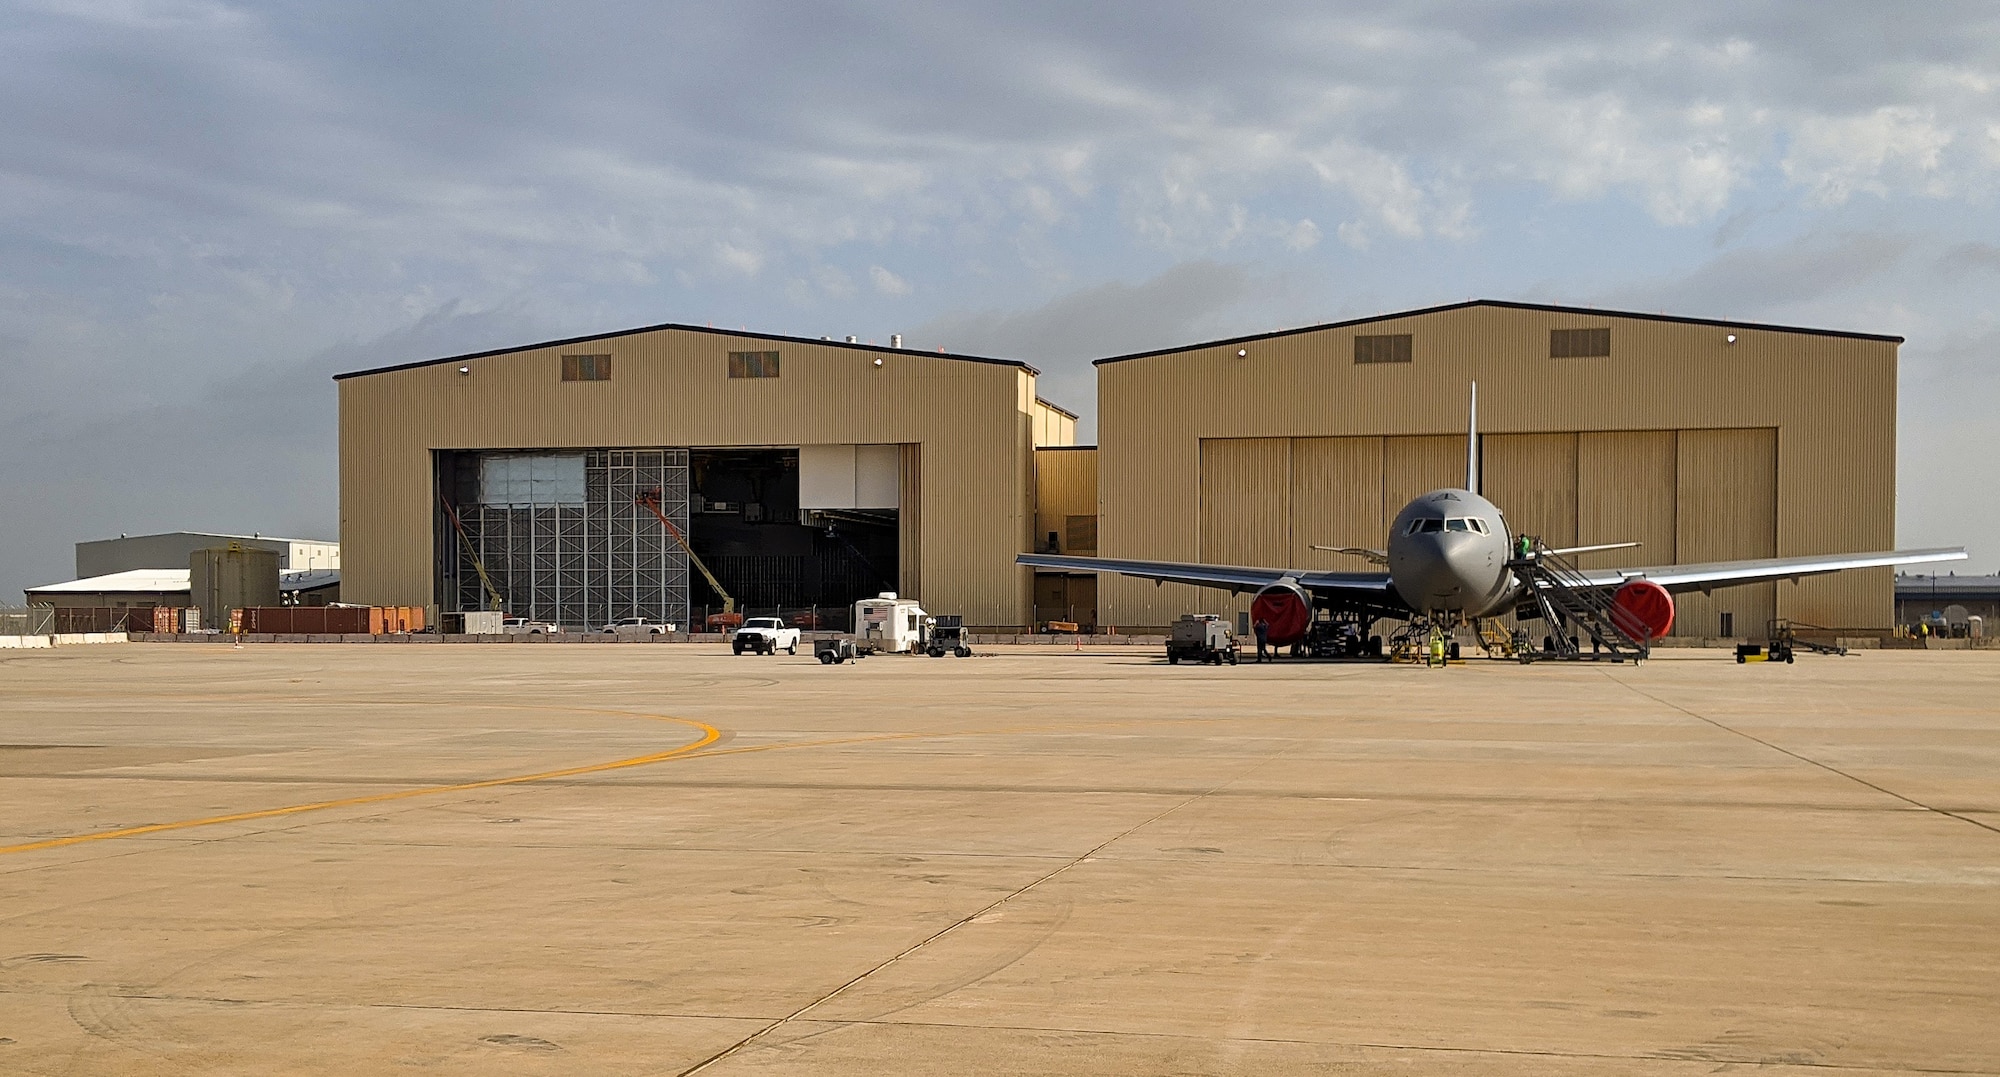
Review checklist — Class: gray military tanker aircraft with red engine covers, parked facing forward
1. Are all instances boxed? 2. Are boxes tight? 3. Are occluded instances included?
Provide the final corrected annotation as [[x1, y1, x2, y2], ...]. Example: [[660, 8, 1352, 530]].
[[1014, 384, 1966, 651]]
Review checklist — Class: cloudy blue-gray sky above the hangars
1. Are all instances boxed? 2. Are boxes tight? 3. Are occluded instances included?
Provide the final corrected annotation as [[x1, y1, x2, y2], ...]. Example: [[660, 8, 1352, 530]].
[[0, 0, 2000, 603]]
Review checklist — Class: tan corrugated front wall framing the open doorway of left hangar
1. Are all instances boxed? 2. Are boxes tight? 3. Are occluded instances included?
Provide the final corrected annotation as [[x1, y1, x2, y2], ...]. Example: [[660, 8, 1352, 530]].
[[338, 330, 1034, 625]]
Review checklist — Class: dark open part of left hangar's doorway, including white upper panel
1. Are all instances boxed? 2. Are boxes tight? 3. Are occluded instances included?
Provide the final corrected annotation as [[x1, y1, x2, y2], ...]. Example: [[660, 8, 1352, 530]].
[[688, 444, 900, 629]]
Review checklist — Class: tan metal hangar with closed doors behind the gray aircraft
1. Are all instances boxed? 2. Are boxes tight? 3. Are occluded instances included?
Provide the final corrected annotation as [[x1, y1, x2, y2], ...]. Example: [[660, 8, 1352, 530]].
[[1080, 300, 1902, 637]]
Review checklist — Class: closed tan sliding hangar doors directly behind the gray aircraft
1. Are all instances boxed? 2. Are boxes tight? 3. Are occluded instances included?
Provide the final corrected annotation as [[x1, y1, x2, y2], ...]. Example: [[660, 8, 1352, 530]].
[[1200, 428, 1778, 637]]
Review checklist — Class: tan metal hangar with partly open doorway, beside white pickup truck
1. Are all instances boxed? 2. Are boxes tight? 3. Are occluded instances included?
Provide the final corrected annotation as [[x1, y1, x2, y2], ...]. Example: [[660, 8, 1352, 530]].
[[336, 324, 1074, 629]]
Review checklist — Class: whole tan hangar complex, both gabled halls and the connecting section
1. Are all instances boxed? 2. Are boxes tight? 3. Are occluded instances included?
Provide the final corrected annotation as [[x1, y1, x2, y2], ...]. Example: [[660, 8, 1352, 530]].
[[340, 302, 1902, 635]]
